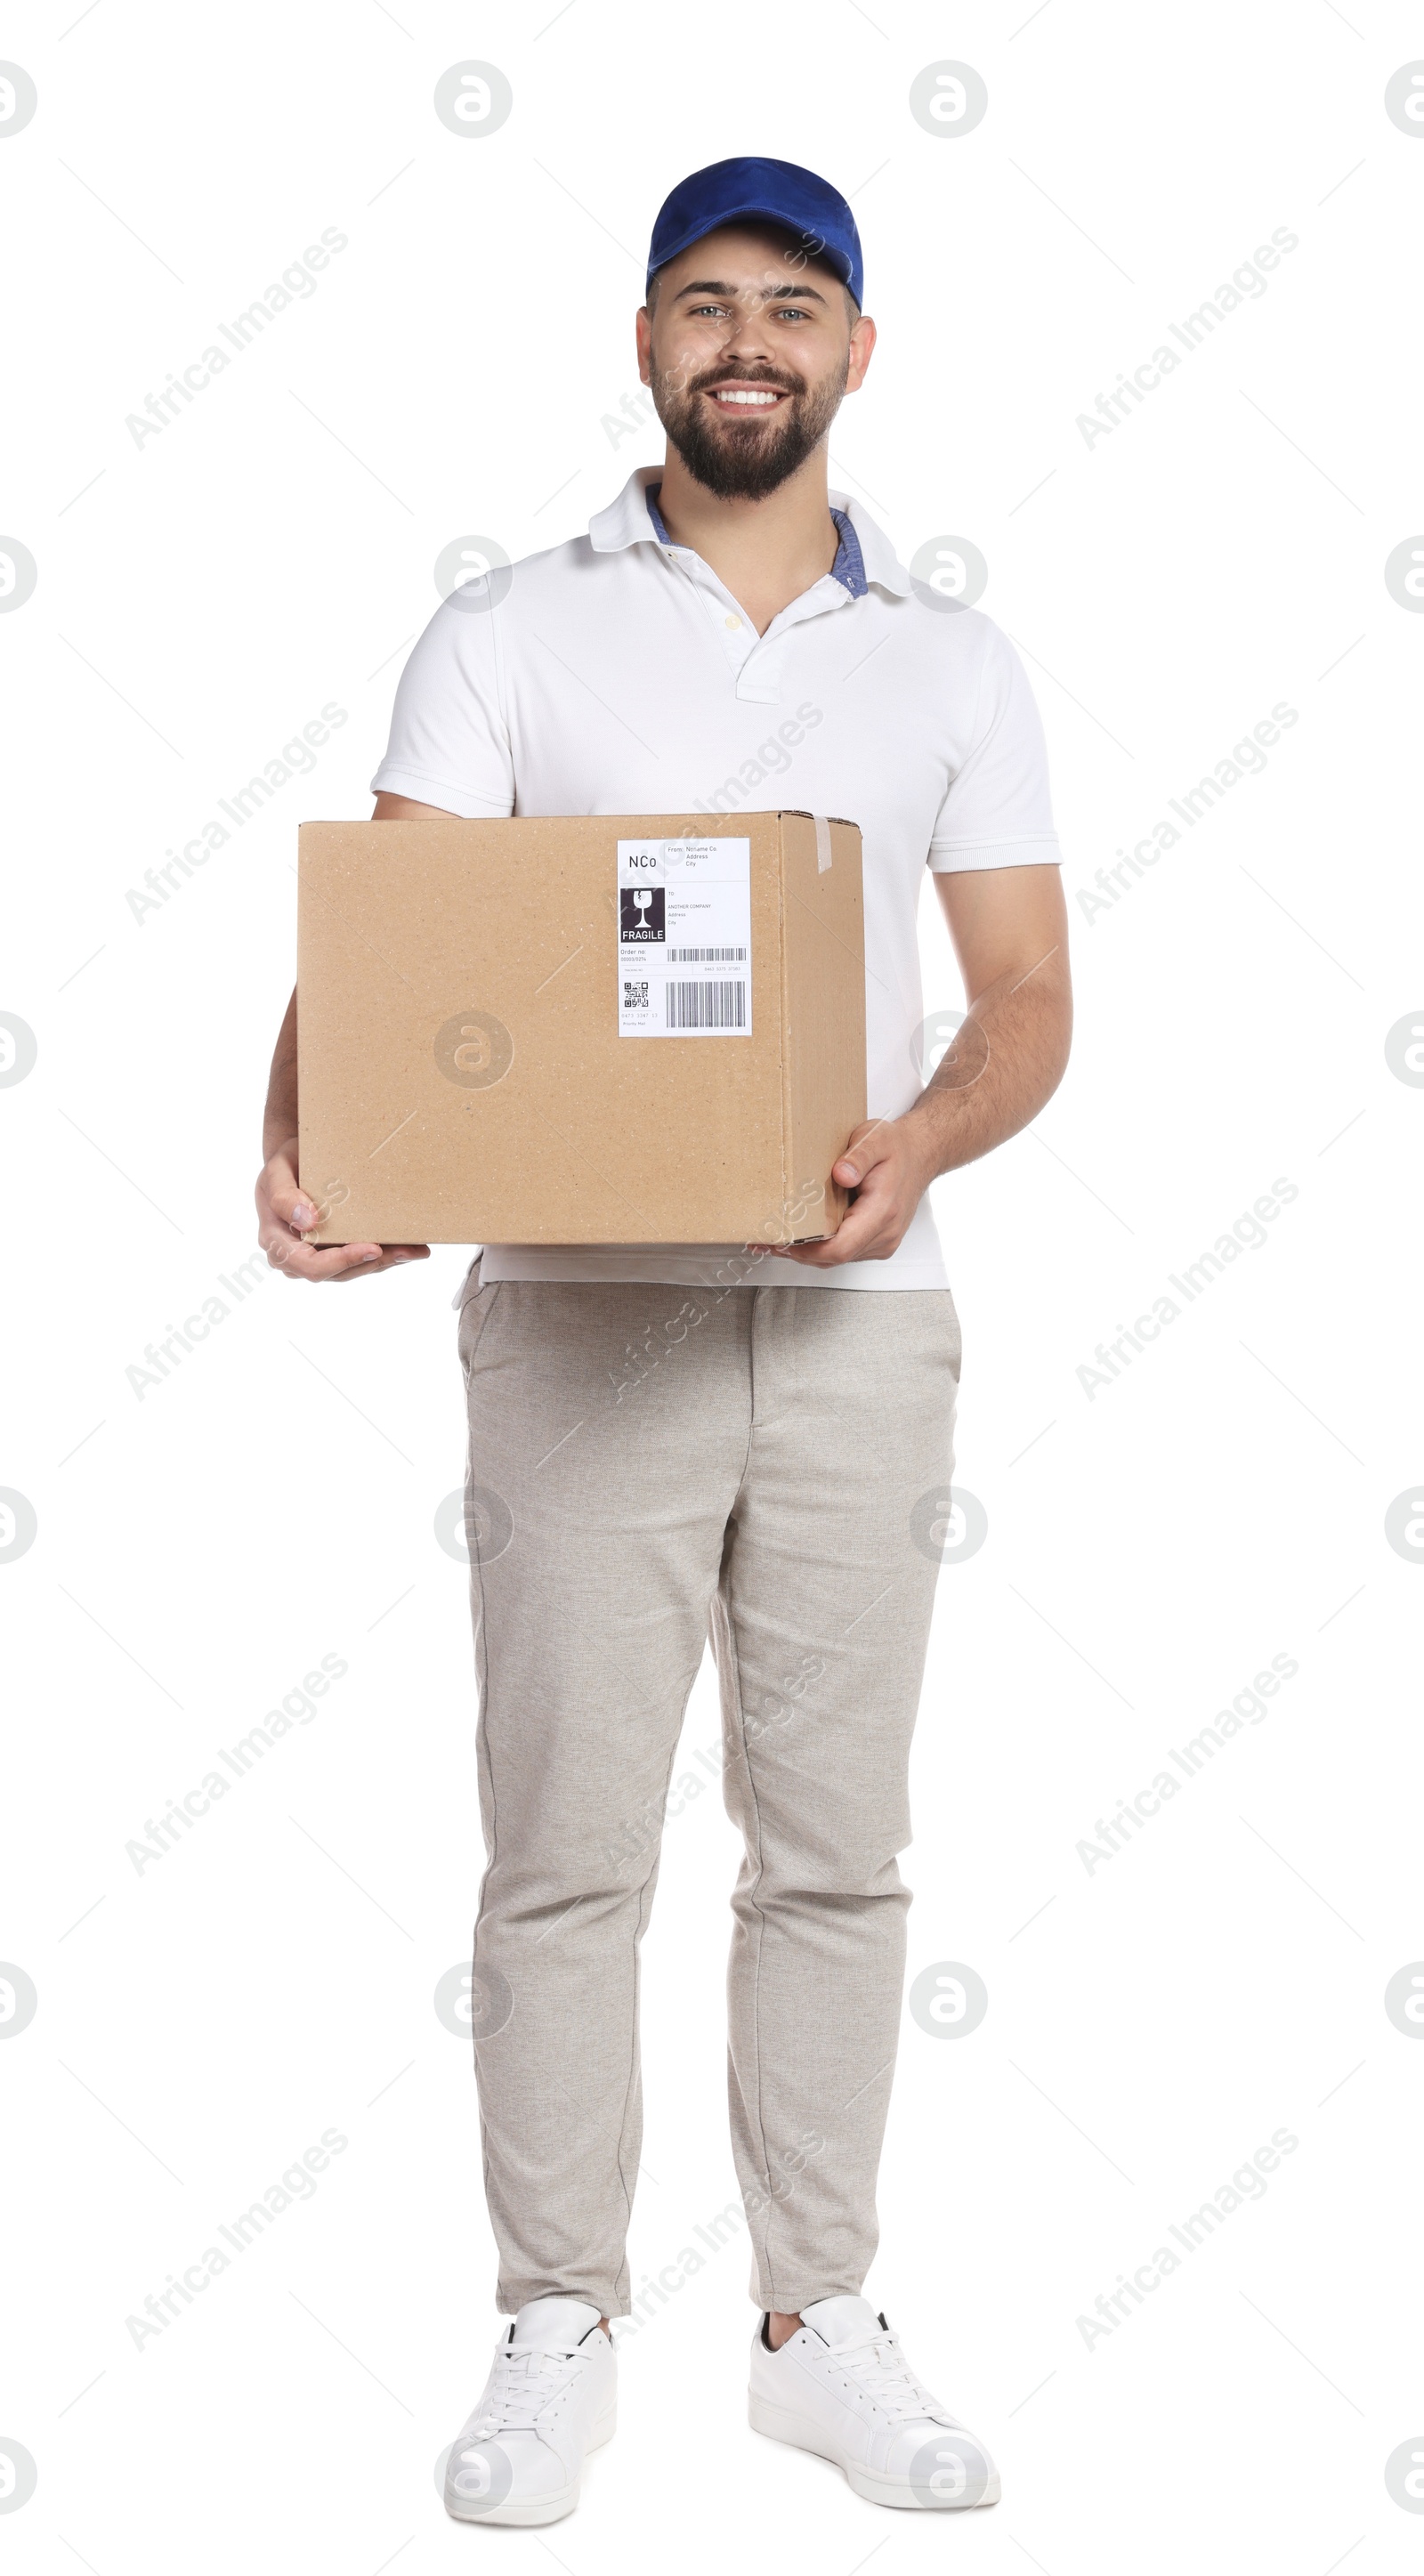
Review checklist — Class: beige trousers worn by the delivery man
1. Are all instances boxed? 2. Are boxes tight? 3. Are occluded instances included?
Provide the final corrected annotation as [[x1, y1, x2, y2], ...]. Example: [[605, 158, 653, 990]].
[[458, 1265, 960, 2316]]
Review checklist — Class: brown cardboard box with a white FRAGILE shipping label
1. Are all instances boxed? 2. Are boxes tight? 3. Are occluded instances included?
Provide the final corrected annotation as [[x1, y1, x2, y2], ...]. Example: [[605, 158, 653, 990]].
[[296, 812, 865, 1244]]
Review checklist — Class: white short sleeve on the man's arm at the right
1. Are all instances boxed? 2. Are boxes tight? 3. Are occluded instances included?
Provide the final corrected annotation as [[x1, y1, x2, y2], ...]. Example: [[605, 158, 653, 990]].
[[929, 619, 1064, 876]]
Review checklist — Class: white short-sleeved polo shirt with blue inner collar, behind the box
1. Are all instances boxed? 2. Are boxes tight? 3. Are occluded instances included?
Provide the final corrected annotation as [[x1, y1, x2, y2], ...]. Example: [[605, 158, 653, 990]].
[[371, 466, 1061, 1288]]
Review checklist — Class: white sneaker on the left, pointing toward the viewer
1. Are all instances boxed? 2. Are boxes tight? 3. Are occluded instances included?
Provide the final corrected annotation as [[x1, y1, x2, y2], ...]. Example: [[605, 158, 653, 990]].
[[446, 2297, 618, 2522]]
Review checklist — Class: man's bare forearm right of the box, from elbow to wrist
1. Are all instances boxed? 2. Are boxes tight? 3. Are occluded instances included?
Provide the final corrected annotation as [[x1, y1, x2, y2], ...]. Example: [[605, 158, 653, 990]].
[[904, 951, 1074, 1178]]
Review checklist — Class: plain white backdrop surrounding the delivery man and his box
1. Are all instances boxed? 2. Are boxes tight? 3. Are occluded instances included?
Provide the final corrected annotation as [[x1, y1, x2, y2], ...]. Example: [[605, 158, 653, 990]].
[[0, 0, 1424, 2576]]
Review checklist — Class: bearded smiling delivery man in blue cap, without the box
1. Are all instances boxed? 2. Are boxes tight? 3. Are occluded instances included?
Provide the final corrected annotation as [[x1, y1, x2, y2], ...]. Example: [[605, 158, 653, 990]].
[[257, 159, 1069, 2522]]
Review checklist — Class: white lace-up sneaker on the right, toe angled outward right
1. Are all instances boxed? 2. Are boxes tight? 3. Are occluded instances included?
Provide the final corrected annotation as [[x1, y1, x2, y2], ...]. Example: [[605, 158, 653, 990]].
[[749, 2297, 999, 2512]]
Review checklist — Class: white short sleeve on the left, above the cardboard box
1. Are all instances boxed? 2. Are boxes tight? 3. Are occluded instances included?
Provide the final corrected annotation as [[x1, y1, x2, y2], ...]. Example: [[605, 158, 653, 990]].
[[371, 593, 515, 819]]
